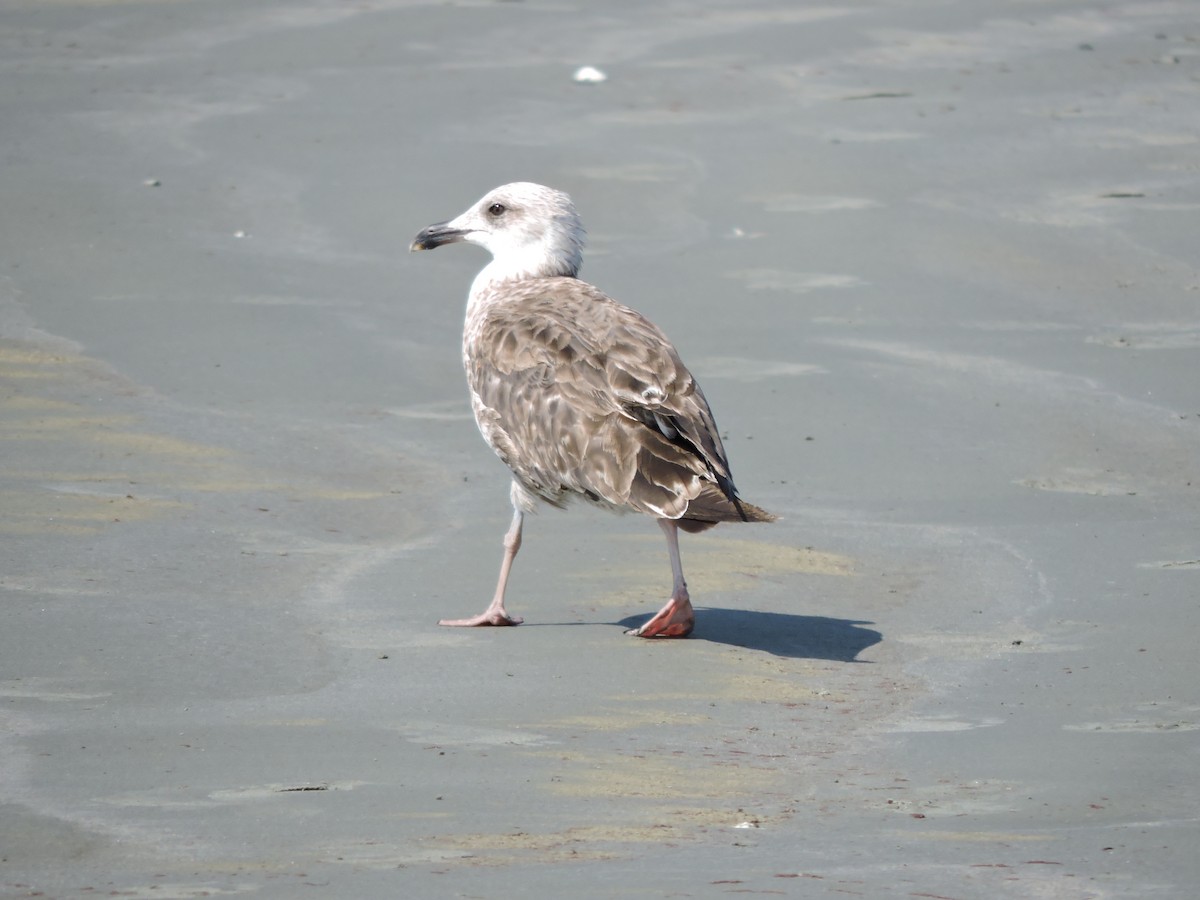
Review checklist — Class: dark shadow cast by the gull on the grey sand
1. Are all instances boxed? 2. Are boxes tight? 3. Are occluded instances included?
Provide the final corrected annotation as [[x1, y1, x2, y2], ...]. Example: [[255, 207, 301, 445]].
[[617, 606, 883, 662]]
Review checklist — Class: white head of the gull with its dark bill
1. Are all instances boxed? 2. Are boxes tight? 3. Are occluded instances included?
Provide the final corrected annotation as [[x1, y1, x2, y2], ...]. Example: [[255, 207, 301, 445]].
[[409, 181, 583, 283]]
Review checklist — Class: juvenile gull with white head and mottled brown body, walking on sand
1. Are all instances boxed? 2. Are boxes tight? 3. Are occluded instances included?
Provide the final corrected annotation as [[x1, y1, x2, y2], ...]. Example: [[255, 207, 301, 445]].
[[410, 182, 775, 637]]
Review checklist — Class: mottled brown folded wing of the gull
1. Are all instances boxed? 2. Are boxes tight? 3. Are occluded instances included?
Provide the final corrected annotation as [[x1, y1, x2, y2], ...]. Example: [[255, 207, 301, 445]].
[[466, 278, 745, 522]]
